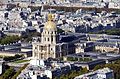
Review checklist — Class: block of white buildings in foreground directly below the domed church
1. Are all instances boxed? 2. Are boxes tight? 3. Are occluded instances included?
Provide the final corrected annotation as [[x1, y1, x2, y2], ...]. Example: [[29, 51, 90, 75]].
[[17, 59, 80, 79]]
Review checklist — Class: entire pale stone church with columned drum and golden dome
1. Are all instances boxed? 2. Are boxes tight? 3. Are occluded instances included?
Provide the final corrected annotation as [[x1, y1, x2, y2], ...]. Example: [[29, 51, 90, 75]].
[[33, 14, 68, 59]]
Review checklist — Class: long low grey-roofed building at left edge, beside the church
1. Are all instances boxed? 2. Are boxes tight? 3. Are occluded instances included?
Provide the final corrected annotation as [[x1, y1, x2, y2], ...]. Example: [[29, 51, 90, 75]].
[[0, 43, 32, 57]]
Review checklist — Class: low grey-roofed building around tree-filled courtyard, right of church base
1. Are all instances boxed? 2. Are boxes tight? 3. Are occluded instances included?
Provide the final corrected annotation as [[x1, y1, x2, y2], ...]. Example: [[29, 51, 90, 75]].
[[63, 52, 120, 70]]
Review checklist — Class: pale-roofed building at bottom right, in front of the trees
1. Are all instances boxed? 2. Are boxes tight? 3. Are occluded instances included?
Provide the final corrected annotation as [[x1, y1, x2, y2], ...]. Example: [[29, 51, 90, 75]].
[[74, 68, 114, 79]]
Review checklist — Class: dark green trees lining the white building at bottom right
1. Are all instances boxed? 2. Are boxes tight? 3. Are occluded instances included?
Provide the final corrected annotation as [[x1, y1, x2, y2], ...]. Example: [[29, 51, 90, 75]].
[[54, 60, 120, 79]]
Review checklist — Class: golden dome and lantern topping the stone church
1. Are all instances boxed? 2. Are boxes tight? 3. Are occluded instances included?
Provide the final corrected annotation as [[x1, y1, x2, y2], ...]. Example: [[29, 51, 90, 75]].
[[44, 14, 56, 29]]
